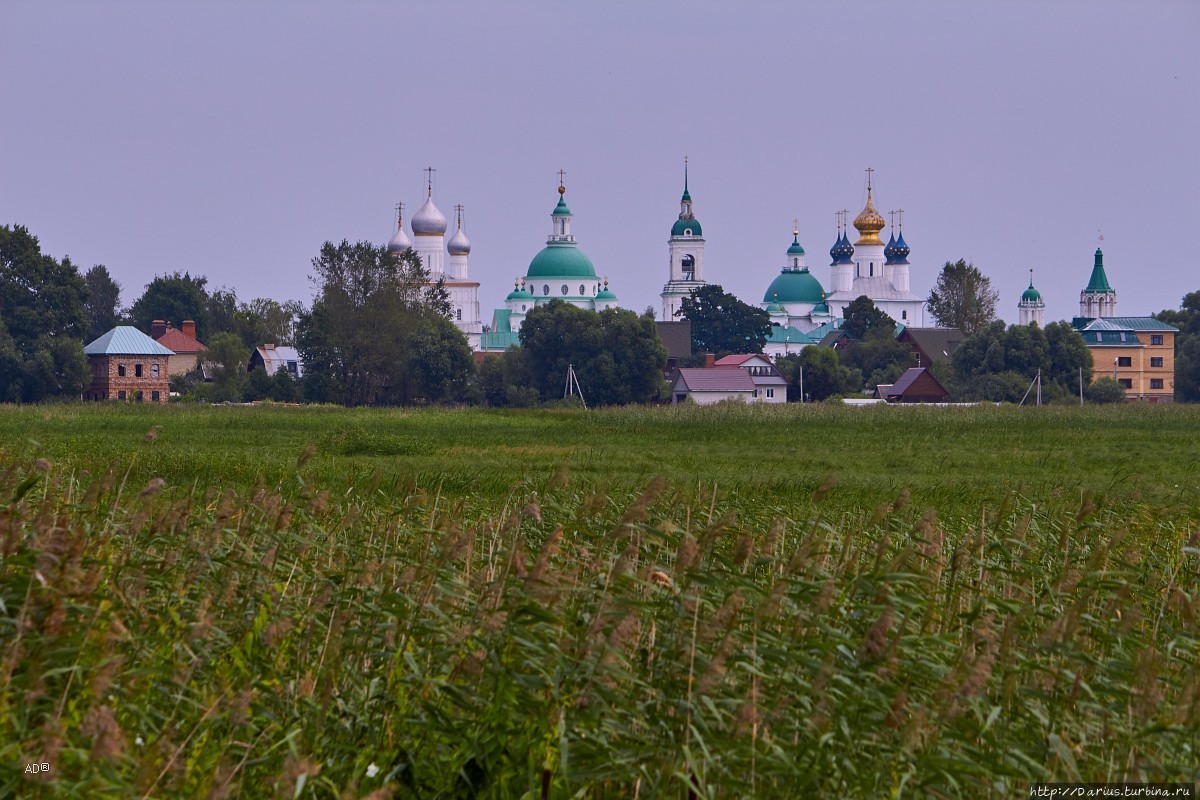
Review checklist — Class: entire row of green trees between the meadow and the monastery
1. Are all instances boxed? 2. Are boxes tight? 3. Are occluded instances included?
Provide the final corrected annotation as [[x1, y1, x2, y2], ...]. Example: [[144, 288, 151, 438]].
[[0, 220, 1200, 407]]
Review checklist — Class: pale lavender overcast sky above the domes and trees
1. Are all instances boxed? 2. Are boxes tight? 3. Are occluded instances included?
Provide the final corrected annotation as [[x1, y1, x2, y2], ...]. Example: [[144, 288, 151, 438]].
[[0, 0, 1200, 323]]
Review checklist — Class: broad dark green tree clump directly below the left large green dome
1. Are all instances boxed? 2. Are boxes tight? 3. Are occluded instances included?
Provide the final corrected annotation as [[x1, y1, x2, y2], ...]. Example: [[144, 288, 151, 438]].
[[521, 300, 667, 405]]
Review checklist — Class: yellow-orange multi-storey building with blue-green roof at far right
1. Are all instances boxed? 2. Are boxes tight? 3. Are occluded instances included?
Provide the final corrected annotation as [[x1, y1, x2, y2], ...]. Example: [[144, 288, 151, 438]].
[[1078, 317, 1178, 403]]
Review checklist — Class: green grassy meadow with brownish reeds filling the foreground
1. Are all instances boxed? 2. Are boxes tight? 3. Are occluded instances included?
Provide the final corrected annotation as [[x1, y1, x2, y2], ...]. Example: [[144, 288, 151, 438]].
[[0, 405, 1200, 799]]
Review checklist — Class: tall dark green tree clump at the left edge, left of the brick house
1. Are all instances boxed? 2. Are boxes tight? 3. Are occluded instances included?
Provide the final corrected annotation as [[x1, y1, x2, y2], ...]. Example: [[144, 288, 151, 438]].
[[0, 225, 88, 403]]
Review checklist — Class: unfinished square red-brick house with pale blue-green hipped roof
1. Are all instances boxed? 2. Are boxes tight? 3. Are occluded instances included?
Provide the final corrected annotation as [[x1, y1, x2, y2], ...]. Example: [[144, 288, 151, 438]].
[[83, 325, 174, 403]]
